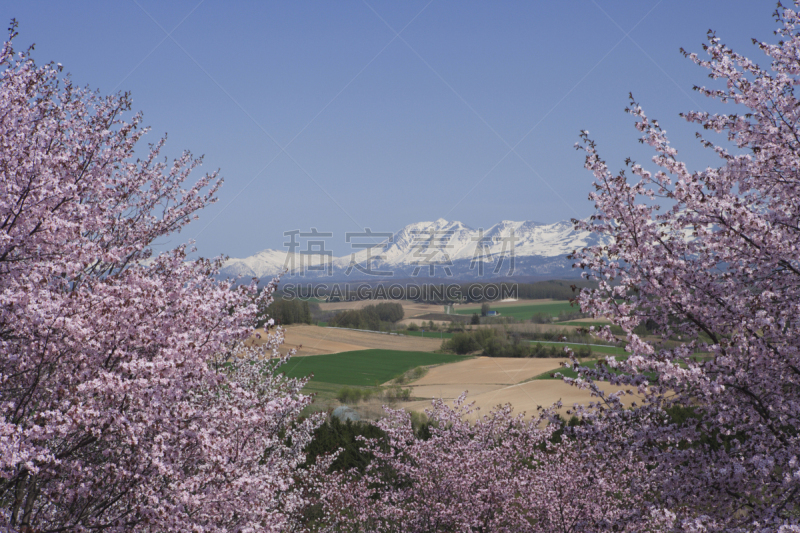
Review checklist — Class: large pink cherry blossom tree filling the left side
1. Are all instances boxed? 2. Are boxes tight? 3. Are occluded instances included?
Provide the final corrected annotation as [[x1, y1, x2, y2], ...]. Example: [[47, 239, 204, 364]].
[[0, 24, 316, 531]]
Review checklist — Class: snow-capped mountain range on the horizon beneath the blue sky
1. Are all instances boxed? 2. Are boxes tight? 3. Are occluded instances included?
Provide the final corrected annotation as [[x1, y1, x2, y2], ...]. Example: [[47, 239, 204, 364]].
[[216, 218, 599, 281]]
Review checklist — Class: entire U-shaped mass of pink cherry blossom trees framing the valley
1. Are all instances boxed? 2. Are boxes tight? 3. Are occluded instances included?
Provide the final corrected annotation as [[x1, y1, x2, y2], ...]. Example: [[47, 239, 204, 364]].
[[0, 2, 800, 533]]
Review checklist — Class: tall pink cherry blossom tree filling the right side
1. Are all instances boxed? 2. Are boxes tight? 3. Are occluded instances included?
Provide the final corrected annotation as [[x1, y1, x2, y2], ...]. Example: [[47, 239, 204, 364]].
[[568, 4, 800, 531]]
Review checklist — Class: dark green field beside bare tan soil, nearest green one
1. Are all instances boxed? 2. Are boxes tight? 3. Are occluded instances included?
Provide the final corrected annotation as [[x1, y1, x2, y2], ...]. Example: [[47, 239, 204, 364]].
[[279, 350, 466, 387]]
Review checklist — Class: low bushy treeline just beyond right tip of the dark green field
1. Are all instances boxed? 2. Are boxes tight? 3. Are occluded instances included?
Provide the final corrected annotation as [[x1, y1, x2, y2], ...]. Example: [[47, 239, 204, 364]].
[[442, 328, 592, 357]]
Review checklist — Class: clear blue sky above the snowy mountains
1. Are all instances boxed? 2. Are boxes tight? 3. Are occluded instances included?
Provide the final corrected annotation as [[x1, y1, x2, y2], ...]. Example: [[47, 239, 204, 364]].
[[0, 0, 775, 257]]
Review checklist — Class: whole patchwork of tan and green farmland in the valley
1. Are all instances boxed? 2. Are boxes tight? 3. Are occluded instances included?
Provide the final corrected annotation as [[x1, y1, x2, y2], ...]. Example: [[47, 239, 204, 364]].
[[247, 300, 626, 419]]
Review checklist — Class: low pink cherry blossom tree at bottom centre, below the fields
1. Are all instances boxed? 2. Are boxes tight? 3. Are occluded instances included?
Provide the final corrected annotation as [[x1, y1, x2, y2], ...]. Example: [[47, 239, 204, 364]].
[[310, 395, 669, 533]]
